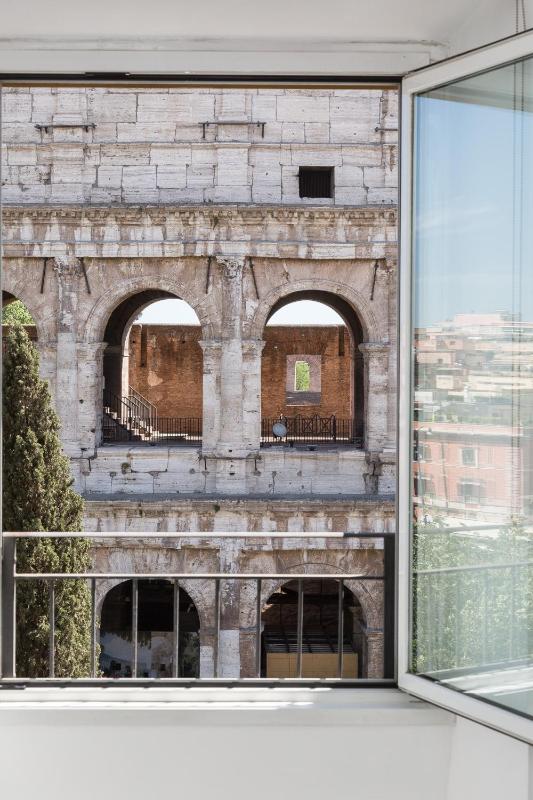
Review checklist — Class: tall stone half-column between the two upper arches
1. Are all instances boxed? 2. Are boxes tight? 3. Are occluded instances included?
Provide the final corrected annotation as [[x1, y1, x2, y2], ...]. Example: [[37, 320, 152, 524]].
[[217, 257, 246, 459]]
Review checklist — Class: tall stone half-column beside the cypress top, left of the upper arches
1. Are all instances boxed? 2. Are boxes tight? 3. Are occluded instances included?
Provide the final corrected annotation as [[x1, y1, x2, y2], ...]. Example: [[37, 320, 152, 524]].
[[54, 256, 82, 456]]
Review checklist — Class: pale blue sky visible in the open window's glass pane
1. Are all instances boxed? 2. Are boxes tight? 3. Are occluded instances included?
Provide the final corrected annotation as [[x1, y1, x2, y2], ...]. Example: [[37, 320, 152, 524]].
[[415, 62, 533, 325]]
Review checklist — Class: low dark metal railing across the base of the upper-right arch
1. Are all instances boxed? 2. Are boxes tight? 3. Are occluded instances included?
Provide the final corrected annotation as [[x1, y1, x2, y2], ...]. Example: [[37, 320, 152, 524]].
[[261, 415, 363, 448]]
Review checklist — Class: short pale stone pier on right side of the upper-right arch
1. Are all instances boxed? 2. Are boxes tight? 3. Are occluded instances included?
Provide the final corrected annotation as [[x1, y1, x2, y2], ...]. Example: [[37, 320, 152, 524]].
[[359, 342, 389, 453]]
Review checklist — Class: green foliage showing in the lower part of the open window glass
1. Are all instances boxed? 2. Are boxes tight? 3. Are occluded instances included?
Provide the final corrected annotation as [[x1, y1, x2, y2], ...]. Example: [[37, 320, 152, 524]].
[[413, 518, 533, 673]]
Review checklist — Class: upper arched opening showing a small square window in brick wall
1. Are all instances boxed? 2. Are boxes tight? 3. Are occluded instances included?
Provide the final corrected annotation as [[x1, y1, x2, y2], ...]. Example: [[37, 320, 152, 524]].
[[261, 290, 365, 447]]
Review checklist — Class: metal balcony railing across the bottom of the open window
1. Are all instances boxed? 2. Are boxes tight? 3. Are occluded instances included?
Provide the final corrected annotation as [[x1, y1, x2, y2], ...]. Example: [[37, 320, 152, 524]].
[[0, 531, 395, 688]]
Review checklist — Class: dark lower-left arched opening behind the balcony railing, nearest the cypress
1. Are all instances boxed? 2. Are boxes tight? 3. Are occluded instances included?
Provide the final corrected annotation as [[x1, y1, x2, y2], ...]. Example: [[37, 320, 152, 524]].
[[100, 580, 200, 678]]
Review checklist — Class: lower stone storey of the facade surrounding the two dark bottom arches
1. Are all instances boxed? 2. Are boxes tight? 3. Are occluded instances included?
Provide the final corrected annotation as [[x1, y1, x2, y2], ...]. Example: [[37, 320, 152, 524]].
[[85, 499, 388, 678]]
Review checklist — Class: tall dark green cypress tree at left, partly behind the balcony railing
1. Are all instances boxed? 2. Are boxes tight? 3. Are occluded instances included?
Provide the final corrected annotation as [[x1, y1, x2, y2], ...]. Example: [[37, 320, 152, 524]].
[[2, 323, 91, 677]]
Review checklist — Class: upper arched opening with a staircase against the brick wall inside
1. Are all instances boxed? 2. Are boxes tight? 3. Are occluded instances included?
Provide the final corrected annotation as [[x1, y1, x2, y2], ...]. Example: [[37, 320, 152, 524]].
[[103, 289, 203, 444]]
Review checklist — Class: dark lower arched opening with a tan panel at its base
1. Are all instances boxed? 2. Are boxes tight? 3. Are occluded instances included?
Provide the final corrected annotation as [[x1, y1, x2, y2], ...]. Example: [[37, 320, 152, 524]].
[[261, 578, 366, 678]]
